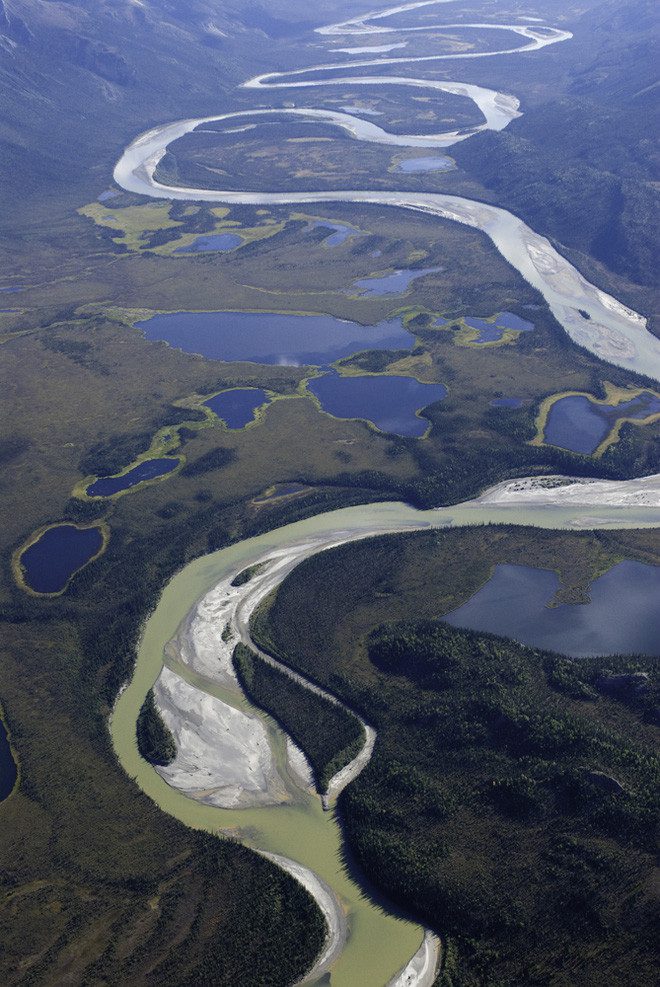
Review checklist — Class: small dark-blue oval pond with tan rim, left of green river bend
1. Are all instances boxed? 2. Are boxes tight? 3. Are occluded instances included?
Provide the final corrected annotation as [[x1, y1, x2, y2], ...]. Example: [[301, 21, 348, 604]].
[[20, 524, 103, 593]]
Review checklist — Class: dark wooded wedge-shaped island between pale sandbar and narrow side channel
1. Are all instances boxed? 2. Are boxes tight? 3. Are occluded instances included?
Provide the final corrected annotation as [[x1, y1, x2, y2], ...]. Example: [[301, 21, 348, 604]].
[[234, 644, 365, 794]]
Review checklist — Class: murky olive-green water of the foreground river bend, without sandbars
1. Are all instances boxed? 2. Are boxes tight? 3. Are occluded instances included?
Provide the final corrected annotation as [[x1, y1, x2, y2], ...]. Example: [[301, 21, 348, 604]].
[[110, 502, 660, 987]]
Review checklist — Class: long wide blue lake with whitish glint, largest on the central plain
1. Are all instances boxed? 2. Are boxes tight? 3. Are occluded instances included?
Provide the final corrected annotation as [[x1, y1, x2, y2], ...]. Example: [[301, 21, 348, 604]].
[[137, 312, 415, 366]]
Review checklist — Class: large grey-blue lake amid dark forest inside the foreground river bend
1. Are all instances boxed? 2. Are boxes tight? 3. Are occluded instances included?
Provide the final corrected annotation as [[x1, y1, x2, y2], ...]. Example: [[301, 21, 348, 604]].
[[442, 561, 660, 657]]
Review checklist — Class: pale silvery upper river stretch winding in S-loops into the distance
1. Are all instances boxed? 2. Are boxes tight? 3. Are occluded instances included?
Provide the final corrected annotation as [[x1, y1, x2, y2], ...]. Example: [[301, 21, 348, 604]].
[[114, 0, 660, 379]]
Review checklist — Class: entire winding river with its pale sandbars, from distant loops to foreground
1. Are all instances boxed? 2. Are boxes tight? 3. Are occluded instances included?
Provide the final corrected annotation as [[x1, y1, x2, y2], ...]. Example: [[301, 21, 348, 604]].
[[110, 0, 660, 987]]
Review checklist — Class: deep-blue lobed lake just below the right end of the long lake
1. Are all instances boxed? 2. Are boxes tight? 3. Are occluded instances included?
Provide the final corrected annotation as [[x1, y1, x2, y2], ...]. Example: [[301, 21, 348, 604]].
[[307, 372, 447, 436]]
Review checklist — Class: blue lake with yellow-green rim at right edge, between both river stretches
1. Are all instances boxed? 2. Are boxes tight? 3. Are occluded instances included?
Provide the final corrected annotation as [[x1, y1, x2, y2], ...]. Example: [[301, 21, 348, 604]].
[[543, 391, 660, 455]]
